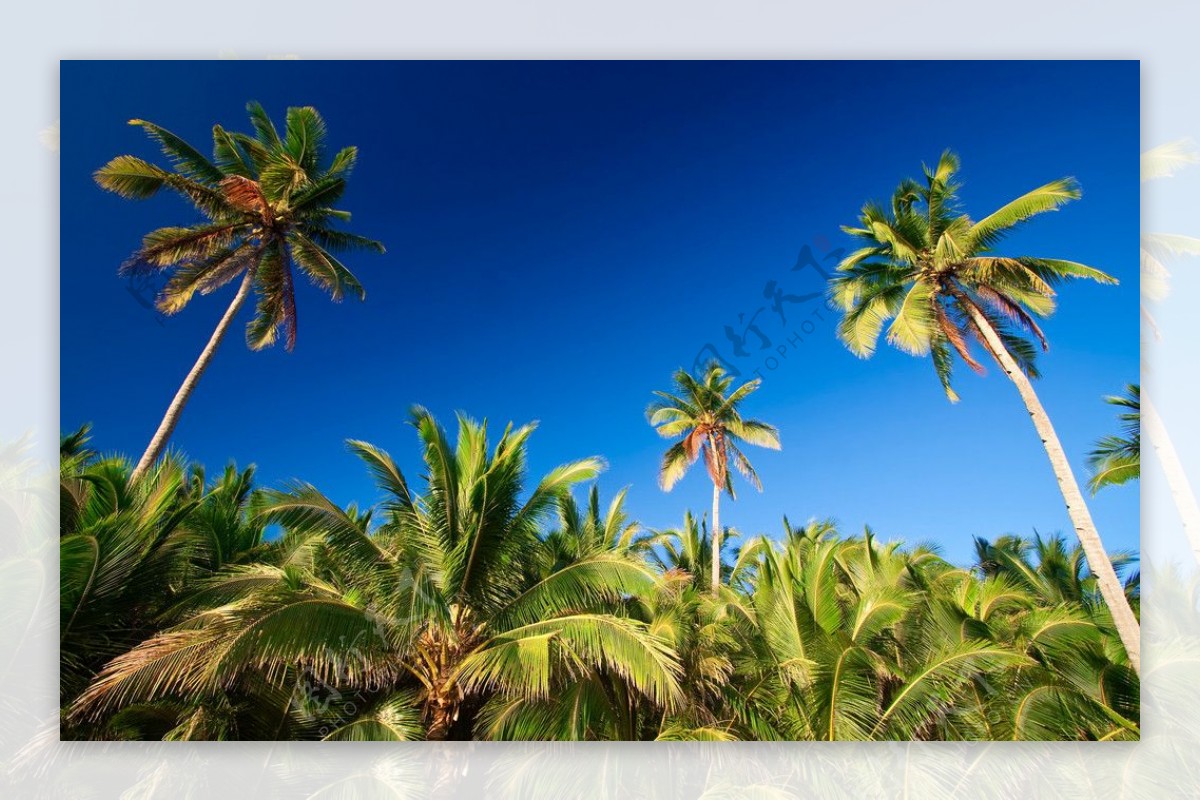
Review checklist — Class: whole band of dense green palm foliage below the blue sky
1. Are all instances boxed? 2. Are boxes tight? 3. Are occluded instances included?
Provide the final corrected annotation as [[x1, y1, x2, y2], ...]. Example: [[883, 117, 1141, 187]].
[[60, 417, 1138, 740]]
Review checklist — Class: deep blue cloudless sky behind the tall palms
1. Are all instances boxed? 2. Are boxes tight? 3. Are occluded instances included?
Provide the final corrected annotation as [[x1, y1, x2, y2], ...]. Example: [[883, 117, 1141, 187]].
[[61, 61, 1139, 561]]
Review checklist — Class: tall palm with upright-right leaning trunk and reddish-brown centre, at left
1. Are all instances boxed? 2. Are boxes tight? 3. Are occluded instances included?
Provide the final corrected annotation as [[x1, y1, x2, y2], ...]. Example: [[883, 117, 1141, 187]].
[[95, 103, 384, 481]]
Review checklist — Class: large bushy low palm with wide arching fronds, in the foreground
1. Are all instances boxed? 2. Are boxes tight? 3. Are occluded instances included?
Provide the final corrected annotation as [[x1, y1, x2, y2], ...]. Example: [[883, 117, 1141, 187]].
[[70, 408, 682, 740]]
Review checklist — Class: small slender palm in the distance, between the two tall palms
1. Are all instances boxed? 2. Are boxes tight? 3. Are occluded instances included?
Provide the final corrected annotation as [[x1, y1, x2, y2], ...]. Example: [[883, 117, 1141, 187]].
[[646, 360, 780, 594]]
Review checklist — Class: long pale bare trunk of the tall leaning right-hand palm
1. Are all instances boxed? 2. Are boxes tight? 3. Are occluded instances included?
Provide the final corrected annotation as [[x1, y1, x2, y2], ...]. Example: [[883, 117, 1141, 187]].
[[955, 293, 1141, 675]]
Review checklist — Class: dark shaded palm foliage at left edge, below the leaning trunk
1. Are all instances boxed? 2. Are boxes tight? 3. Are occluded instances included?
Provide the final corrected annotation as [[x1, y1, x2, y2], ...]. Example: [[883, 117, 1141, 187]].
[[60, 428, 263, 698]]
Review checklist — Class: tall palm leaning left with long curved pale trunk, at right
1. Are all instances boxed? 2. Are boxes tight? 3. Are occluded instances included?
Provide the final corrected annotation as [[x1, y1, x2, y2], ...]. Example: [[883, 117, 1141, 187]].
[[829, 151, 1140, 668]]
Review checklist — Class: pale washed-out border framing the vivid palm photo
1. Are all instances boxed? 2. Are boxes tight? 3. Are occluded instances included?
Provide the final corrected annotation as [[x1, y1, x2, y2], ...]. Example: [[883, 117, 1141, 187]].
[[0, 0, 1200, 799]]
